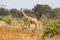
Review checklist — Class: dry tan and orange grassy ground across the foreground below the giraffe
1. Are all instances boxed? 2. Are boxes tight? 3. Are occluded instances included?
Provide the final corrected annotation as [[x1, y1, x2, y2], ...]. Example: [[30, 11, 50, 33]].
[[0, 21, 60, 40]]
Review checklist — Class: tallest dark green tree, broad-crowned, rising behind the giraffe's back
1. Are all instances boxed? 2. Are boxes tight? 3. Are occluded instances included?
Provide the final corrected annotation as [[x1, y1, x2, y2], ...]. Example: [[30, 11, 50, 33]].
[[32, 4, 52, 19]]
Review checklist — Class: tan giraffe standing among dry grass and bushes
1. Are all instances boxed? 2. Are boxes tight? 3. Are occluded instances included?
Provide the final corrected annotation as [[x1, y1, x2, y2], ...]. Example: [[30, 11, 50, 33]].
[[21, 9, 38, 29]]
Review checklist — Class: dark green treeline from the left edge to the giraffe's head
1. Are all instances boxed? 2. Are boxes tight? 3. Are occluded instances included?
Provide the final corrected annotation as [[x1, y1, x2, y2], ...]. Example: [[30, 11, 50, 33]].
[[0, 8, 22, 17]]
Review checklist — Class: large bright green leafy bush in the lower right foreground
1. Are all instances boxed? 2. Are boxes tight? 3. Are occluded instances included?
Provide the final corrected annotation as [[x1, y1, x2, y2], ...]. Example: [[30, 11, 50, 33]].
[[44, 20, 60, 37]]
